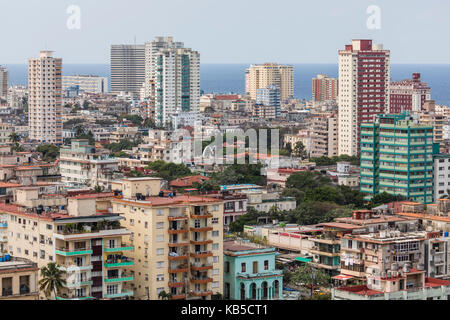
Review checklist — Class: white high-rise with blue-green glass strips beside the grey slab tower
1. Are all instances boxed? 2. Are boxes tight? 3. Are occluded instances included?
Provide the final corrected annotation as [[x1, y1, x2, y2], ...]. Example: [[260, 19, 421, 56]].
[[144, 37, 200, 125]]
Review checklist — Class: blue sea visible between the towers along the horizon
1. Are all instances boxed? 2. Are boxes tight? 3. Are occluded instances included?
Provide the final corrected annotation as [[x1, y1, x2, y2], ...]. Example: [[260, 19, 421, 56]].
[[6, 64, 450, 106]]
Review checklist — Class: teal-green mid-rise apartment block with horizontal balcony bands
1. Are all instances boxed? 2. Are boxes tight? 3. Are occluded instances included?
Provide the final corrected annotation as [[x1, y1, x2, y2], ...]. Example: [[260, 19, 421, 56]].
[[360, 113, 439, 204]]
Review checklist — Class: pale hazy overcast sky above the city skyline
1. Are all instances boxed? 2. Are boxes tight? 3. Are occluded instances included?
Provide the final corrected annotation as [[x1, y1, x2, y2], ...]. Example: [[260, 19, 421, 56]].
[[0, 0, 450, 64]]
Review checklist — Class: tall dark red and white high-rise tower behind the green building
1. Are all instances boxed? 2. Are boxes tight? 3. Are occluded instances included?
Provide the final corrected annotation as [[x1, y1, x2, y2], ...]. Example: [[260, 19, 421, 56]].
[[338, 40, 390, 156]]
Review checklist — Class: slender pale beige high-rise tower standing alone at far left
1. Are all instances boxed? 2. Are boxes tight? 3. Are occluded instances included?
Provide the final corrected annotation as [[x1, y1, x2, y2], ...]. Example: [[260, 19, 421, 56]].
[[28, 51, 62, 144]]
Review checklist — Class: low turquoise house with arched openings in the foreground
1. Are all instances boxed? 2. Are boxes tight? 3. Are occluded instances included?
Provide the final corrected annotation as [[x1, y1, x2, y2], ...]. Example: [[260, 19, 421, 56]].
[[223, 241, 283, 300]]
